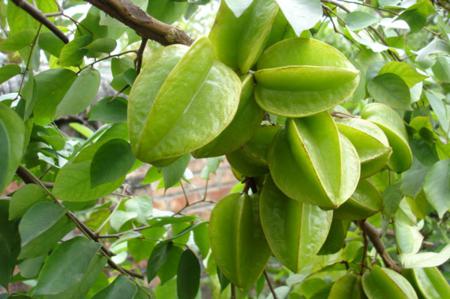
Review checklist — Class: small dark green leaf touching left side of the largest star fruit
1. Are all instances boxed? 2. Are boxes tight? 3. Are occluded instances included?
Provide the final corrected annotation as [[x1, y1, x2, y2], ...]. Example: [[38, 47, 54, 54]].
[[89, 97, 127, 123]]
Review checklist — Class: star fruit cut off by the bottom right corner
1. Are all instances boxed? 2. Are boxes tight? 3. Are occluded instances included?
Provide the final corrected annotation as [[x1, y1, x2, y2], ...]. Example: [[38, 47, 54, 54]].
[[404, 267, 450, 299]]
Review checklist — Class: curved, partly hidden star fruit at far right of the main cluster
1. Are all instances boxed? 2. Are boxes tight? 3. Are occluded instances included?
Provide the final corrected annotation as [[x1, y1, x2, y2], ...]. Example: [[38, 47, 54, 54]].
[[361, 103, 412, 172]]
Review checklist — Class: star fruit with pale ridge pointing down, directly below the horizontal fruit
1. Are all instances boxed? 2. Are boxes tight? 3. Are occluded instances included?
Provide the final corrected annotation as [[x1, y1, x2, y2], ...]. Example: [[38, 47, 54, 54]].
[[269, 112, 360, 209]]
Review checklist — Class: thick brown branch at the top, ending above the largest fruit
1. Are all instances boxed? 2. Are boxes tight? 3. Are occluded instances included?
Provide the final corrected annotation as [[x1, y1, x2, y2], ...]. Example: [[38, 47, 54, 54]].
[[85, 0, 192, 45]]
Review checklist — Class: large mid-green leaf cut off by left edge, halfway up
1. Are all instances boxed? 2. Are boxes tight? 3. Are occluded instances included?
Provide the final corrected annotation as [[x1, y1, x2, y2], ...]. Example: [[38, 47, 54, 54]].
[[0, 103, 25, 192]]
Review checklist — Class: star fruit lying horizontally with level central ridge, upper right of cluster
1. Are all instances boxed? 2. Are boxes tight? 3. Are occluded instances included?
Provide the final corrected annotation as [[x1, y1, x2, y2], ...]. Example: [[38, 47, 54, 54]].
[[255, 38, 359, 117]]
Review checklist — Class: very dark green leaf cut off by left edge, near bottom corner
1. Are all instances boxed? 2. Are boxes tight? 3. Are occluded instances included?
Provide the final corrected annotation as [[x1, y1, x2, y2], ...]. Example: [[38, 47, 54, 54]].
[[0, 200, 20, 288]]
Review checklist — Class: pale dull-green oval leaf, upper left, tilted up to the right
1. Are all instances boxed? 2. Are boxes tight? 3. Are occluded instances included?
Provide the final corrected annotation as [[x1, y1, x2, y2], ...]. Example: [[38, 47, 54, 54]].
[[56, 68, 100, 118]]
